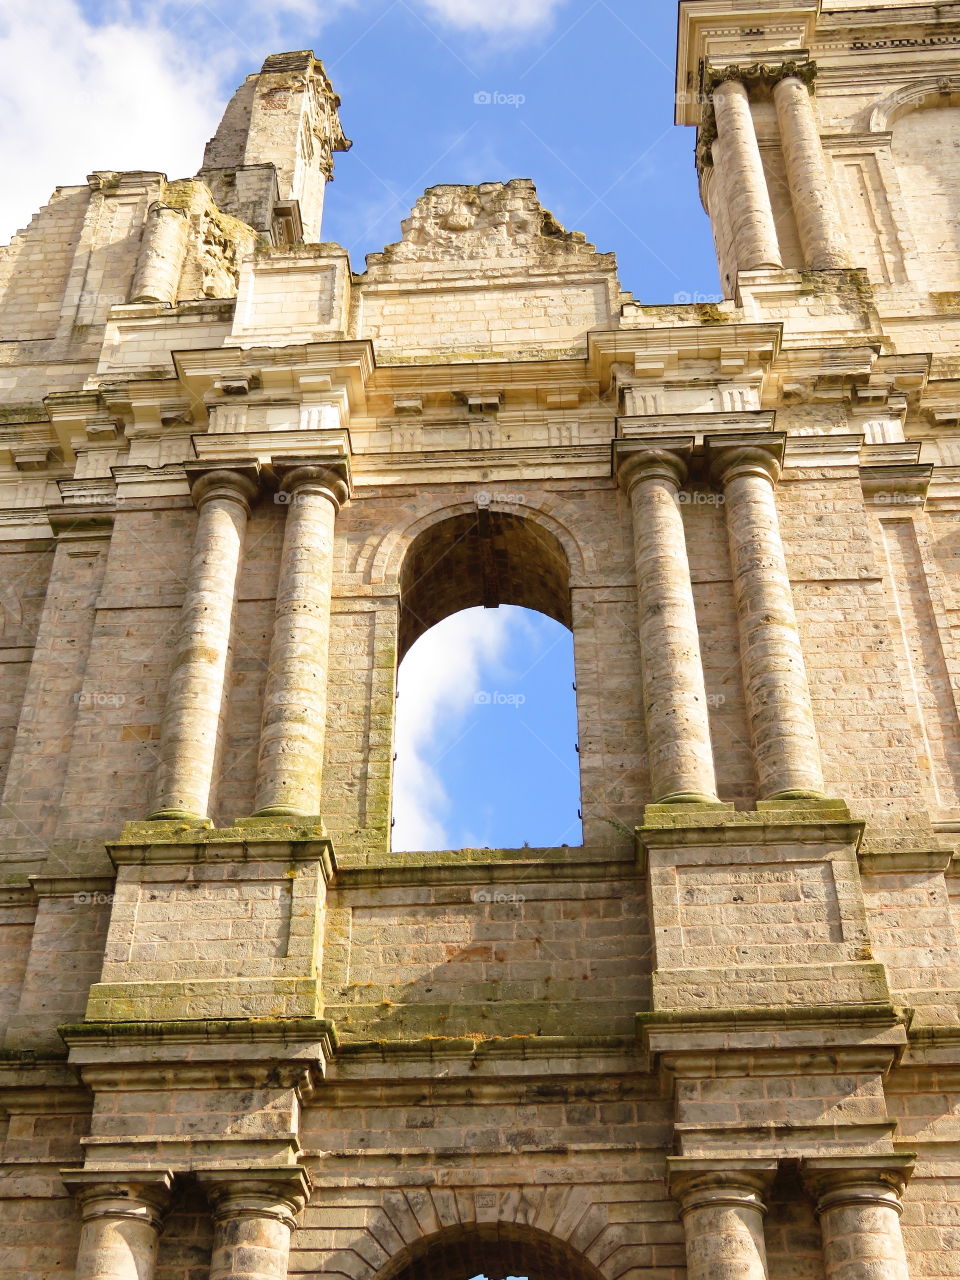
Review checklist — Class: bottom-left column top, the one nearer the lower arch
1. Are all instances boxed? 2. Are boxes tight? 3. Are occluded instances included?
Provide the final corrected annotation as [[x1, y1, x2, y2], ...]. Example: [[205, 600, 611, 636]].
[[200, 1169, 310, 1280]]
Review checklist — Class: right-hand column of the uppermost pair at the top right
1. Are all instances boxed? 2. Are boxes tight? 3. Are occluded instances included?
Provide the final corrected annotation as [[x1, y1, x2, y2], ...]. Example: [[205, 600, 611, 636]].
[[773, 76, 850, 271]]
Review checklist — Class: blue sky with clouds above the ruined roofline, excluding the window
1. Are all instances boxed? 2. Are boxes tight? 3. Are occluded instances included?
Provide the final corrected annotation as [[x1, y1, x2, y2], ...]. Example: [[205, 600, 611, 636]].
[[0, 0, 717, 302]]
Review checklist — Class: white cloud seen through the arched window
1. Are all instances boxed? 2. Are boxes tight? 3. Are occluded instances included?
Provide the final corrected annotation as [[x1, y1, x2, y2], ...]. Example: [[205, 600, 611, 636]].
[[393, 609, 516, 850]]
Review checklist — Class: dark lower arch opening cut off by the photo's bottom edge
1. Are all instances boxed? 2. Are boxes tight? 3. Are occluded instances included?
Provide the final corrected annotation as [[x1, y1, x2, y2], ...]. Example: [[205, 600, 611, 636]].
[[378, 1222, 602, 1280]]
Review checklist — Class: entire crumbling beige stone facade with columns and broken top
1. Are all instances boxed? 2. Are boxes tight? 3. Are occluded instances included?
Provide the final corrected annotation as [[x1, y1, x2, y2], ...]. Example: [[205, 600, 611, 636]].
[[0, 0, 960, 1280]]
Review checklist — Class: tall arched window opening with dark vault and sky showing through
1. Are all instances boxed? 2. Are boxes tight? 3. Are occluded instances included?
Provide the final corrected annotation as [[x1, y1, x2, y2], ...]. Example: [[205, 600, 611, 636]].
[[393, 508, 582, 851]]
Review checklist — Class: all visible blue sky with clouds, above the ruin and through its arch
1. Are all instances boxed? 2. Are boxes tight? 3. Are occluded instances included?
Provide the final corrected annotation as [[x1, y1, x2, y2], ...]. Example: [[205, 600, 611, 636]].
[[0, 0, 718, 849]]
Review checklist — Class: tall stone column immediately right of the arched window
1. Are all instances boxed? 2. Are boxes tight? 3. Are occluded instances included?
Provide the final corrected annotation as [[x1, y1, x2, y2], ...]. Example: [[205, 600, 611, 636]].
[[616, 440, 718, 804]]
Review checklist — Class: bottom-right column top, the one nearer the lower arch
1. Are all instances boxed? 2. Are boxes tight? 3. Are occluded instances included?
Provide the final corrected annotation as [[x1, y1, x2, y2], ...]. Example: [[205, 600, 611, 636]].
[[671, 1158, 776, 1280]]
